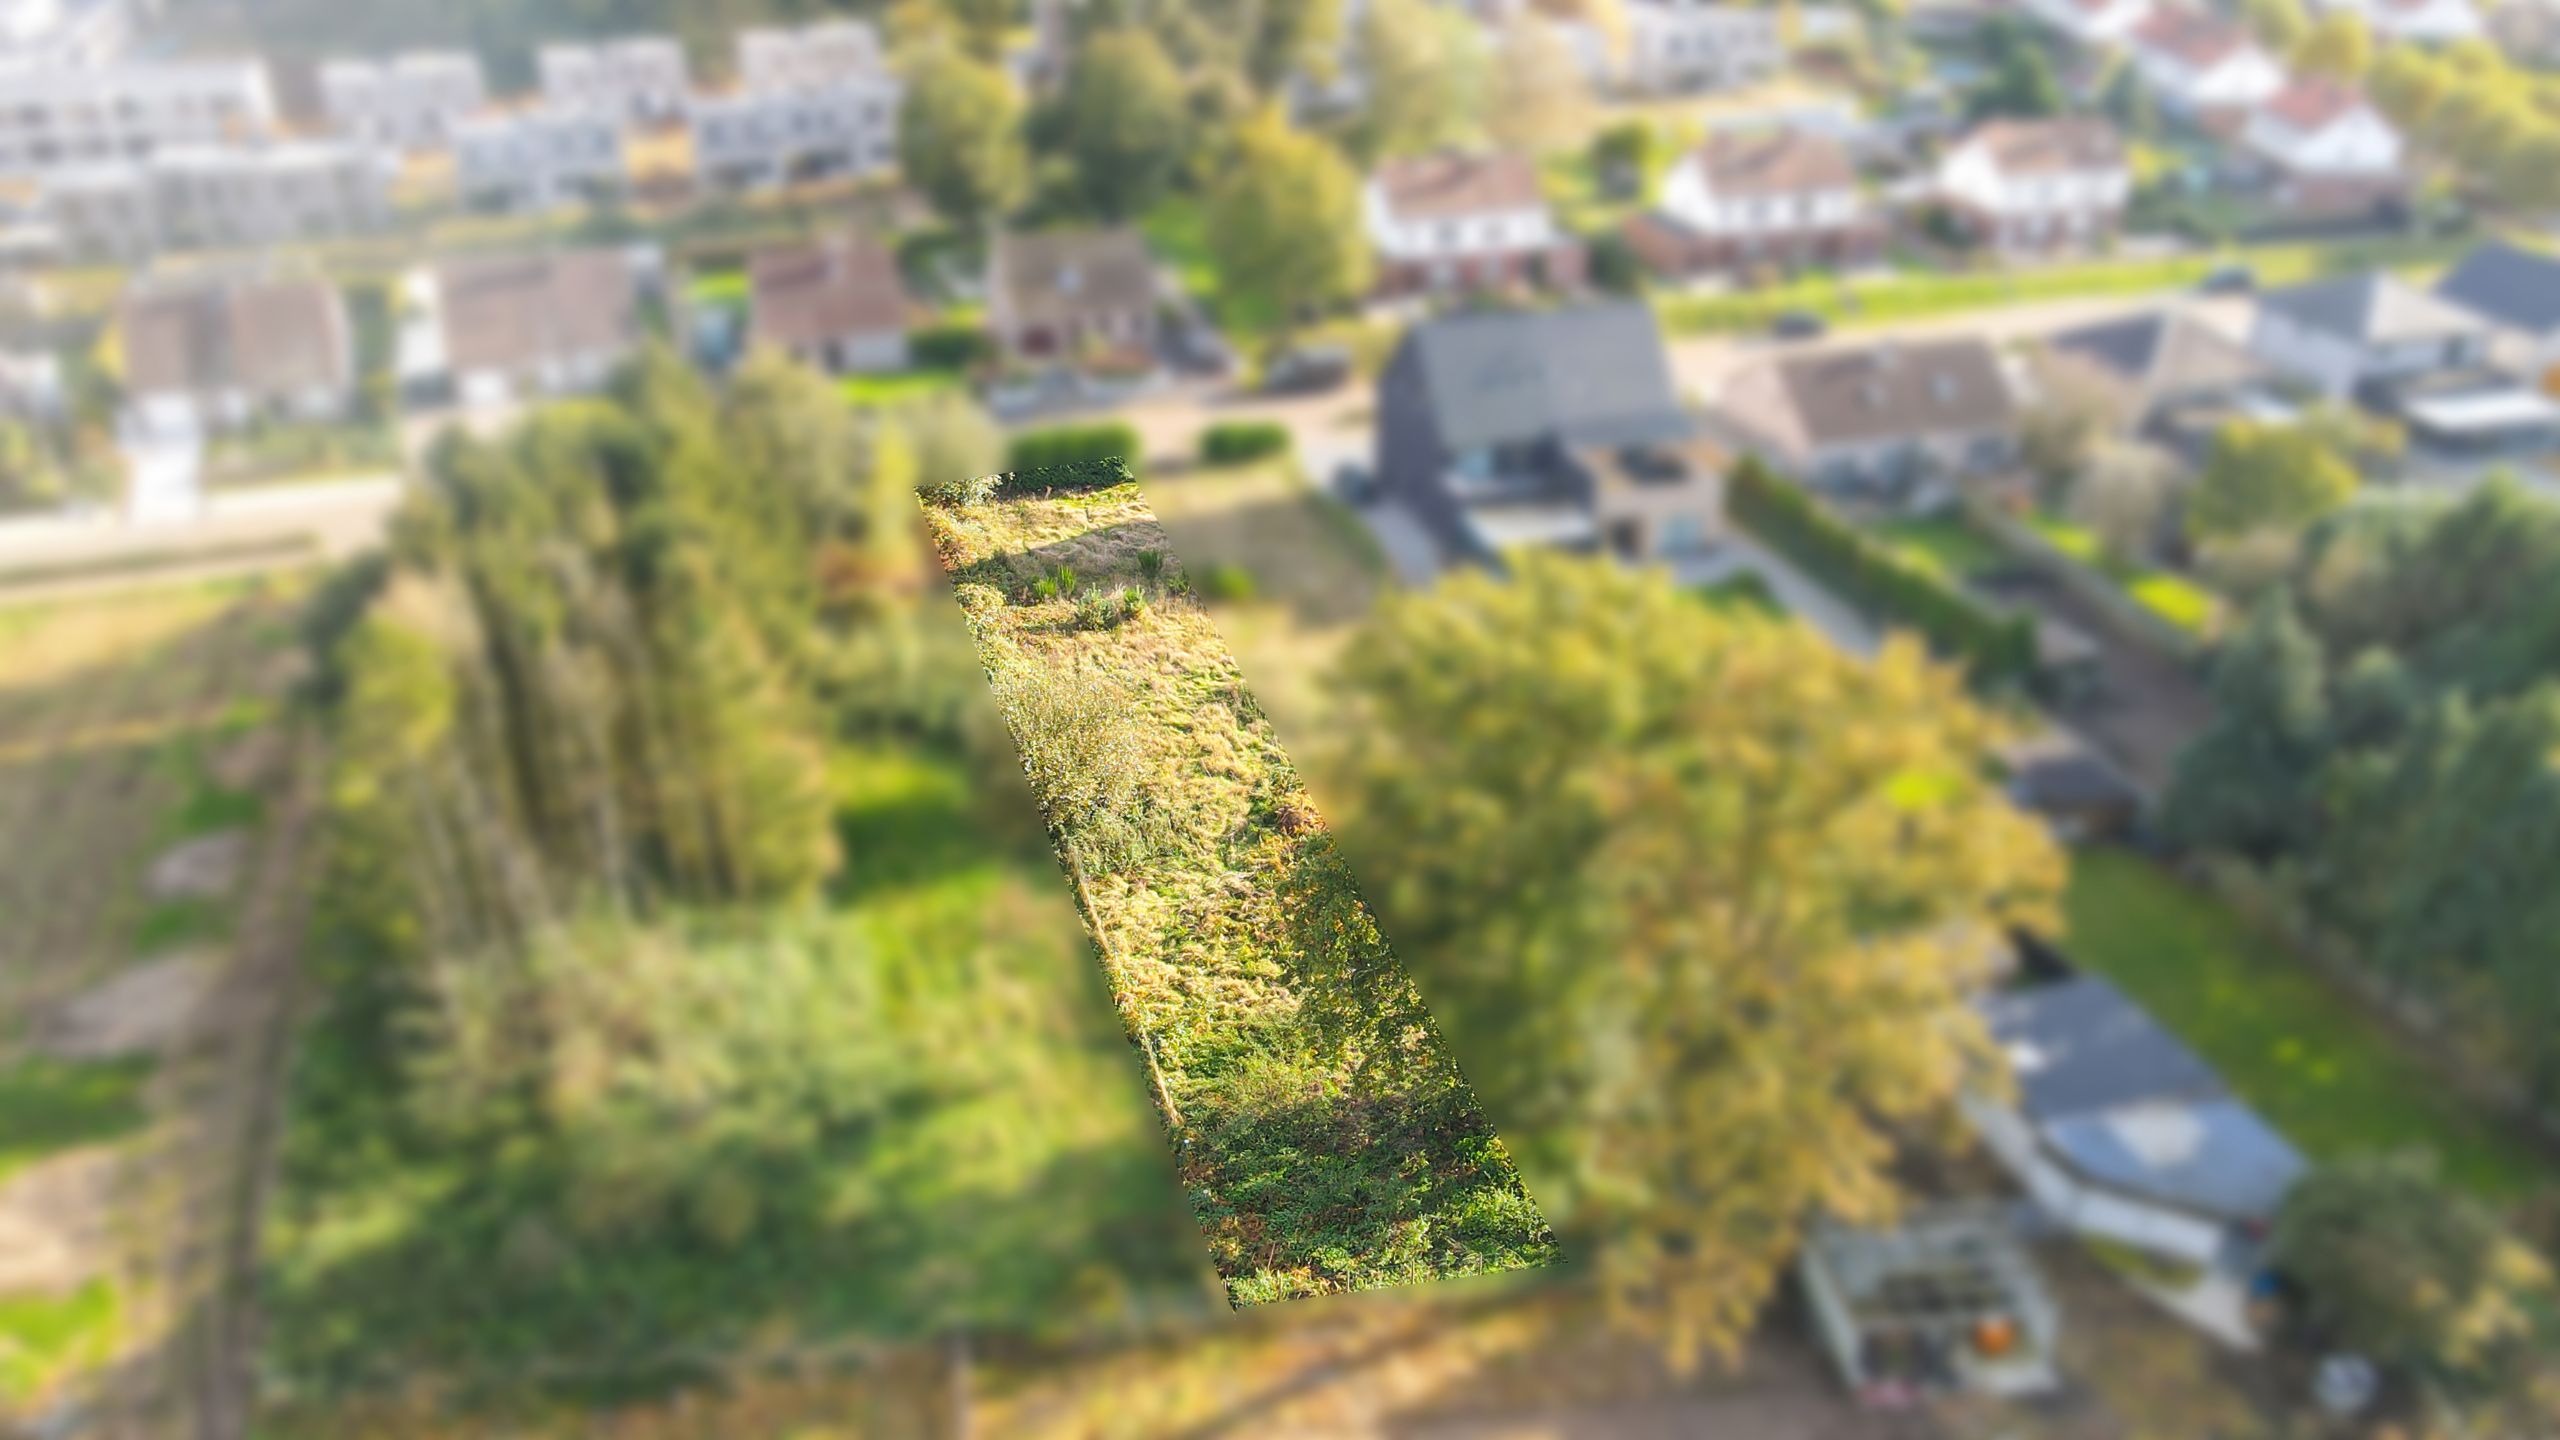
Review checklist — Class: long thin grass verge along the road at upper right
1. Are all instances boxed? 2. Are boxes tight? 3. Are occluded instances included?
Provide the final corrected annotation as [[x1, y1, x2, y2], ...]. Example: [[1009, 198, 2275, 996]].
[[1656, 241, 2473, 336]]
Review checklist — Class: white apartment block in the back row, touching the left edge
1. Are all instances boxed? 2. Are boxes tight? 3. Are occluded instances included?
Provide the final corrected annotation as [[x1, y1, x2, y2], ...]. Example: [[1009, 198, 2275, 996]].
[[0, 59, 276, 174]]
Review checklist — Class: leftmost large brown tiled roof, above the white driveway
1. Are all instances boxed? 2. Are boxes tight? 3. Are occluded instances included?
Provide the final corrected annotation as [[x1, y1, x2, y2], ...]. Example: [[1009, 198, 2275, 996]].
[[118, 277, 353, 397]]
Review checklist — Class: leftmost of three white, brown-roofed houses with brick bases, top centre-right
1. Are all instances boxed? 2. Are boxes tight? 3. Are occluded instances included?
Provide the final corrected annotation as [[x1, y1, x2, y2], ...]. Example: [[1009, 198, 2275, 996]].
[[1362, 151, 1582, 295]]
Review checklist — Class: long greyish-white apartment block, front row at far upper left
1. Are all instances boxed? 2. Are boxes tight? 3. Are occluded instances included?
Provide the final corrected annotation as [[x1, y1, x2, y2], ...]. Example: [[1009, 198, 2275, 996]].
[[44, 141, 392, 261]]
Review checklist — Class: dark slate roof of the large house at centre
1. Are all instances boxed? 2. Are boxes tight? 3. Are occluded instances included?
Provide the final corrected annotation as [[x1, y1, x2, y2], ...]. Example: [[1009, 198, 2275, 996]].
[[1405, 302, 1690, 451]]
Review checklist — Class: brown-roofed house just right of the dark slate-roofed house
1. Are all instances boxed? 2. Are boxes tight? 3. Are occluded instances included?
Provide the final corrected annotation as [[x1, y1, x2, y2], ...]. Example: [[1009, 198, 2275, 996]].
[[1720, 338, 2017, 505]]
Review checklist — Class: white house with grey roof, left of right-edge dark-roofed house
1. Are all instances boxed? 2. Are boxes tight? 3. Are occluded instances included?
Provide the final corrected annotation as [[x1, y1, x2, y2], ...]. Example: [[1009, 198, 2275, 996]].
[[2250, 272, 2491, 400]]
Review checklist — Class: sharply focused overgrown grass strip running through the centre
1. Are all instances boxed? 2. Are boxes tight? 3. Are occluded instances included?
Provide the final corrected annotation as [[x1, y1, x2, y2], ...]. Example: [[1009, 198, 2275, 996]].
[[927, 466, 1554, 1307]]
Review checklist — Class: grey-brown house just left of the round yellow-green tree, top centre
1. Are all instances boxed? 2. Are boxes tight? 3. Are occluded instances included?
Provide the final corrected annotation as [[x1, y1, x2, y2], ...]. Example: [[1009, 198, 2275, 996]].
[[986, 228, 1160, 369]]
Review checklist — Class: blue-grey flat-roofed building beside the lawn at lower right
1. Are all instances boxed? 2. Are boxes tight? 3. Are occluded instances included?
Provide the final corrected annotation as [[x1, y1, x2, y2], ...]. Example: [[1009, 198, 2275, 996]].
[[1961, 976, 2304, 1266]]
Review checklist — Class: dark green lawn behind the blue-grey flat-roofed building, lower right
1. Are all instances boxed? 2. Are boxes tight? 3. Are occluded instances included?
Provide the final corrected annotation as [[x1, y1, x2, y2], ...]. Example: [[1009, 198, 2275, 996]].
[[2066, 851, 2560, 1199]]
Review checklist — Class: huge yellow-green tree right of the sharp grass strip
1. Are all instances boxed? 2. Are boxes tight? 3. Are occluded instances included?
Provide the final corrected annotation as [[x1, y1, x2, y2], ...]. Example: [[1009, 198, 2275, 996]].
[[1339, 556, 2061, 1358]]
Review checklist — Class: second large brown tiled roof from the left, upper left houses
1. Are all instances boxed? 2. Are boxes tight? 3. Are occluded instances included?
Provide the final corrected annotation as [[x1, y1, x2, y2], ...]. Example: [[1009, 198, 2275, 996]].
[[438, 251, 640, 374]]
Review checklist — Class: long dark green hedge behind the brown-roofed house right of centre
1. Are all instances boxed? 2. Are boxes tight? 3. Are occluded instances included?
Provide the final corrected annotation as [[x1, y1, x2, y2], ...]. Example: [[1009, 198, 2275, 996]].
[[1725, 459, 2035, 682]]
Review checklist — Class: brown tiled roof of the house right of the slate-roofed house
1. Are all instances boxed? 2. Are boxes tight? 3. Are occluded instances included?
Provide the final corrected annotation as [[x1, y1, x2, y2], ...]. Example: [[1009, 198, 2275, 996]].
[[1779, 341, 2017, 446]]
